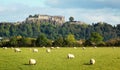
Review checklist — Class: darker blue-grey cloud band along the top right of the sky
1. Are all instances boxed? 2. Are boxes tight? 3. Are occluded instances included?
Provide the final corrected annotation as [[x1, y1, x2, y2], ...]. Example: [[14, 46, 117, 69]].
[[45, 0, 120, 9]]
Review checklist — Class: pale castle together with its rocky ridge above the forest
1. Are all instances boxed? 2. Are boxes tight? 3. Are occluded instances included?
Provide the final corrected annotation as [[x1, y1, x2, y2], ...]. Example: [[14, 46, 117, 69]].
[[4, 14, 86, 25]]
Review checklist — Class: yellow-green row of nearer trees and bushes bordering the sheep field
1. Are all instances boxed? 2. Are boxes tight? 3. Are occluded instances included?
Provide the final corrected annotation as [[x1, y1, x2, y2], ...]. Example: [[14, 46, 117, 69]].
[[0, 32, 120, 47]]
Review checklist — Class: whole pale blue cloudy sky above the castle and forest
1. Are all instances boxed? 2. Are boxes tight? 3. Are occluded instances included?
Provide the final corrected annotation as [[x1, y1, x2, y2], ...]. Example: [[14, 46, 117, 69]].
[[0, 0, 120, 25]]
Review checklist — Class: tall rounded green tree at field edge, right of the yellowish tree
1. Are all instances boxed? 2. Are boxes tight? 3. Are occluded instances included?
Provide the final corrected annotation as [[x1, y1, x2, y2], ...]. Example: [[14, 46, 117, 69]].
[[90, 32, 103, 45]]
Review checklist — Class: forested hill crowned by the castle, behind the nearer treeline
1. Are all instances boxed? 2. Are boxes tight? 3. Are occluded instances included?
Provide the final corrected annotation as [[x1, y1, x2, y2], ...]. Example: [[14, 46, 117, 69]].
[[0, 15, 120, 41]]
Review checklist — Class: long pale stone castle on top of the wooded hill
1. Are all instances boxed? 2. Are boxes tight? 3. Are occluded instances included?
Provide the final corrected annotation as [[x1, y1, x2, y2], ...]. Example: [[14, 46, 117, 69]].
[[26, 14, 65, 25]]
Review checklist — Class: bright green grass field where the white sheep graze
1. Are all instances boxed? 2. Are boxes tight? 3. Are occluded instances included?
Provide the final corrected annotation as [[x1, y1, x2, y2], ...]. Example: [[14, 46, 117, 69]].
[[0, 47, 120, 70]]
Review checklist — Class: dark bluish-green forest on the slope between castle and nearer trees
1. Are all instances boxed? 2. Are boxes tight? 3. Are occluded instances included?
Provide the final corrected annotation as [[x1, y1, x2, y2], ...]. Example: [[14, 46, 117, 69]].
[[0, 22, 120, 41]]
